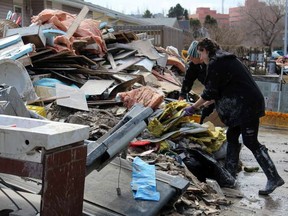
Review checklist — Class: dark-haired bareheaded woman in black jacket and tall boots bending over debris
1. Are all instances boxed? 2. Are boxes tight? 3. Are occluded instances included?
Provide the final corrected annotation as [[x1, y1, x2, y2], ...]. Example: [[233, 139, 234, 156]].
[[184, 38, 284, 195]]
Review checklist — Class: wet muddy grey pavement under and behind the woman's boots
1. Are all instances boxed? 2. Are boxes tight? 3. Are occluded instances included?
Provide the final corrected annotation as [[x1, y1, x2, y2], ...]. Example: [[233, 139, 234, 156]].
[[220, 127, 288, 216]]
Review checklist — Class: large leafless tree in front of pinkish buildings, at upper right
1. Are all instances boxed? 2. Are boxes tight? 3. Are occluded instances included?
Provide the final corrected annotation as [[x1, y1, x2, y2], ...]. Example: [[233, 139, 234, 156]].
[[242, 0, 285, 49]]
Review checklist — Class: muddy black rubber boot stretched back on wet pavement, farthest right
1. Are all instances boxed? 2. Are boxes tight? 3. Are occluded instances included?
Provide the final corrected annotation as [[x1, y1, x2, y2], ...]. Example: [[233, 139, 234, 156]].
[[253, 145, 285, 195]]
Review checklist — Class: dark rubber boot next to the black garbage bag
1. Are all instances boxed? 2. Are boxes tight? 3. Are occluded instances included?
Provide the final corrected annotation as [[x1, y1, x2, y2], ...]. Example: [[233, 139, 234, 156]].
[[224, 143, 241, 178]]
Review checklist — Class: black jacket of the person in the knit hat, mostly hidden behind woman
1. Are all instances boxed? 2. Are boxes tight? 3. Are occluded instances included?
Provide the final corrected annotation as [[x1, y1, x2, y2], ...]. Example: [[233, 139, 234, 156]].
[[180, 62, 206, 98]]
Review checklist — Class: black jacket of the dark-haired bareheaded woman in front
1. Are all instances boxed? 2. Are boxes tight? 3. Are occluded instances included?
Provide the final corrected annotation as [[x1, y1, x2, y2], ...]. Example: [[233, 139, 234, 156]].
[[201, 50, 265, 126]]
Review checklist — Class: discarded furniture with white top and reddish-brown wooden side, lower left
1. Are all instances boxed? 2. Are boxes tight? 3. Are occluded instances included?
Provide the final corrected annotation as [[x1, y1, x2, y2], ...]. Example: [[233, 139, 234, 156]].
[[0, 115, 89, 216]]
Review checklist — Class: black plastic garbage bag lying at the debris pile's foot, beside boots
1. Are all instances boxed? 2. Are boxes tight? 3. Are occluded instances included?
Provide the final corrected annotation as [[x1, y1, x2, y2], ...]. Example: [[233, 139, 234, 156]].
[[183, 149, 235, 188]]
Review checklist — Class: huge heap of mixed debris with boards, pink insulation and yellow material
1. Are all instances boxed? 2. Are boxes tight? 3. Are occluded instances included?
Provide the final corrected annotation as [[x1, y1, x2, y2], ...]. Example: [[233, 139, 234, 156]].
[[0, 7, 238, 215]]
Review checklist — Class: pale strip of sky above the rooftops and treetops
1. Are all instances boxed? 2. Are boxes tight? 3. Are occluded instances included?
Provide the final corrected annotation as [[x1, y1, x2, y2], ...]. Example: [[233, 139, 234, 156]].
[[85, 0, 245, 15]]
